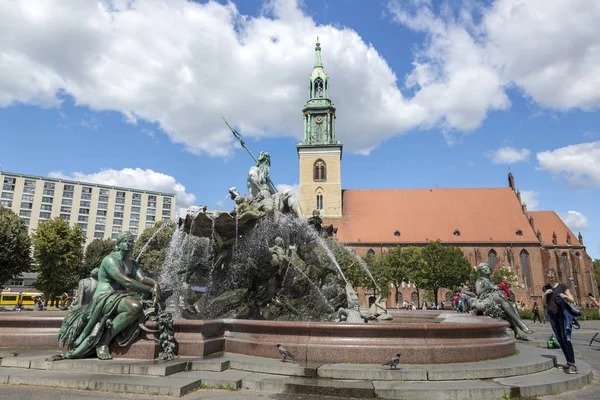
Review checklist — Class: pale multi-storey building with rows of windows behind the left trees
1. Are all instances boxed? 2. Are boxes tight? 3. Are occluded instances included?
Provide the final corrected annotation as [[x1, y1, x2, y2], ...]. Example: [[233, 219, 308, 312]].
[[0, 172, 176, 243]]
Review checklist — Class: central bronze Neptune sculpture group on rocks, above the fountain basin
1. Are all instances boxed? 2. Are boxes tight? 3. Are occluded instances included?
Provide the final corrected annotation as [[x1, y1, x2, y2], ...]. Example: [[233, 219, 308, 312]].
[[166, 138, 347, 321]]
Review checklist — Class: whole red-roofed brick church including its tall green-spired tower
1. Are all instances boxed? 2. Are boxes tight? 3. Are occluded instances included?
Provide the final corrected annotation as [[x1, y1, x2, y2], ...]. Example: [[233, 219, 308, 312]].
[[297, 42, 597, 307]]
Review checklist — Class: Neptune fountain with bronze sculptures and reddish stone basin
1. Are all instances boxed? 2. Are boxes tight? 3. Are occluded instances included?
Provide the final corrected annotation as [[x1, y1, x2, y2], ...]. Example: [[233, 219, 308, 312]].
[[35, 124, 516, 363]]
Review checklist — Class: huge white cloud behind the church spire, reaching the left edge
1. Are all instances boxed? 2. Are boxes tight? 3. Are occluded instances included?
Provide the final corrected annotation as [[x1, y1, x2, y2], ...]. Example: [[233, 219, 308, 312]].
[[0, 0, 422, 156]]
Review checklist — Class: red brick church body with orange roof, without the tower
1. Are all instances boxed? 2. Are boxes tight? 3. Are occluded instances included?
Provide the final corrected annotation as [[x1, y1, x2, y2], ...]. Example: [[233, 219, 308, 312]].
[[324, 174, 595, 307]]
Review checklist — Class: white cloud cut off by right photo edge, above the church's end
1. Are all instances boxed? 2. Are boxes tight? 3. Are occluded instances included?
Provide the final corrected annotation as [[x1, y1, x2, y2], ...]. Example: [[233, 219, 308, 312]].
[[537, 141, 600, 187]]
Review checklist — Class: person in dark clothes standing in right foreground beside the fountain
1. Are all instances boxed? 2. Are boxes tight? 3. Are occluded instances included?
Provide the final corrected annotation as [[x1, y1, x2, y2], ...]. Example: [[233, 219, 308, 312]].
[[542, 269, 577, 374]]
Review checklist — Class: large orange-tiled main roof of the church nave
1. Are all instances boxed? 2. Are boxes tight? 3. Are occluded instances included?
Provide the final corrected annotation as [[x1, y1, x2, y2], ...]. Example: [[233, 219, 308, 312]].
[[323, 188, 540, 245]]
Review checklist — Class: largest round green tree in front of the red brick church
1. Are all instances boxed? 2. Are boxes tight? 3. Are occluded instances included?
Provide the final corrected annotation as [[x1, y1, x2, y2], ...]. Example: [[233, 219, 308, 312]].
[[417, 240, 471, 303]]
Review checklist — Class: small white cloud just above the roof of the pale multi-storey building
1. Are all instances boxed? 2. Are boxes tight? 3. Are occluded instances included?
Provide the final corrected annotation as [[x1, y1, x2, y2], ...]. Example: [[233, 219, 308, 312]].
[[48, 168, 196, 207]]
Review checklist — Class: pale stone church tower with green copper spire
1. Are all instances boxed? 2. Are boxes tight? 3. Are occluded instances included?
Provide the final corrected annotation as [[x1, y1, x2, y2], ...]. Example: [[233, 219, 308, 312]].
[[297, 38, 342, 218]]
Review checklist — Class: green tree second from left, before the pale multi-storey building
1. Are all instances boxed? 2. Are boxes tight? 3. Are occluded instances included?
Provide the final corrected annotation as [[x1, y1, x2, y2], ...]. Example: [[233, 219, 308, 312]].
[[32, 217, 85, 300]]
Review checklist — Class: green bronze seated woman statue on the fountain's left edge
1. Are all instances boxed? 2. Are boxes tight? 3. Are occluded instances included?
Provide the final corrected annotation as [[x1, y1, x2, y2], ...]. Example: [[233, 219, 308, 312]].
[[50, 232, 160, 361]]
